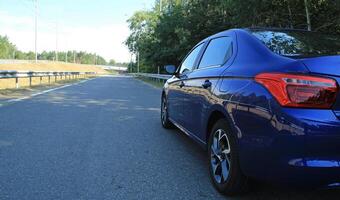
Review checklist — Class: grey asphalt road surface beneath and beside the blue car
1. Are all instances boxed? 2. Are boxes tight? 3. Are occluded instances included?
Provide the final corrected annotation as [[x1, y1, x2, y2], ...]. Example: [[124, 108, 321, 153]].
[[0, 77, 340, 199]]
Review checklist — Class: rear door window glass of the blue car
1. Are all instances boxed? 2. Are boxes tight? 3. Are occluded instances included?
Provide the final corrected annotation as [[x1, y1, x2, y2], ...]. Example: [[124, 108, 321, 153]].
[[198, 37, 233, 69]]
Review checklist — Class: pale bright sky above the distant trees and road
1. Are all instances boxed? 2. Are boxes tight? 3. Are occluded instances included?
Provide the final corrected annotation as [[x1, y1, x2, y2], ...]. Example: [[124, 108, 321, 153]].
[[0, 0, 154, 61]]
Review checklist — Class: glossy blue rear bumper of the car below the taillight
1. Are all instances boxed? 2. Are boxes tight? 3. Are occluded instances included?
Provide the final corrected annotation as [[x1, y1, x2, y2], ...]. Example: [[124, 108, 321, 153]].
[[241, 109, 340, 187]]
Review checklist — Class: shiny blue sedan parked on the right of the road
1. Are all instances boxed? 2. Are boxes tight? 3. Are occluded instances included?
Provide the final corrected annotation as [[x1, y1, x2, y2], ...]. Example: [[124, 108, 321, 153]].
[[161, 29, 340, 195]]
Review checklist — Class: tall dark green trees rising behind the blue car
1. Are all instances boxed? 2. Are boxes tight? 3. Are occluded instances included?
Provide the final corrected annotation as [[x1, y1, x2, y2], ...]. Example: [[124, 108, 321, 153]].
[[125, 0, 340, 72]]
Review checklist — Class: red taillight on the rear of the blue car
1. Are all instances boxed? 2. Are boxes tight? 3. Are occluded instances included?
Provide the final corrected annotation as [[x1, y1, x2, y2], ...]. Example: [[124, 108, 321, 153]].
[[255, 73, 338, 109]]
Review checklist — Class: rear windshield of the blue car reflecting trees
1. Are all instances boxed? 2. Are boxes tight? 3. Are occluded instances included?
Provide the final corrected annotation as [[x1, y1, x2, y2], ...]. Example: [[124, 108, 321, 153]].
[[252, 30, 340, 58]]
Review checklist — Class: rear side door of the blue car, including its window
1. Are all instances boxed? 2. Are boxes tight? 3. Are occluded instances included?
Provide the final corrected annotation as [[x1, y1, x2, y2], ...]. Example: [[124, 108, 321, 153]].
[[183, 36, 233, 141]]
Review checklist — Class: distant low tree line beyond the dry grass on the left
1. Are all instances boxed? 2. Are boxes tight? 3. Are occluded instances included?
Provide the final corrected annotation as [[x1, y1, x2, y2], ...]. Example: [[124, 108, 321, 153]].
[[0, 35, 122, 65]]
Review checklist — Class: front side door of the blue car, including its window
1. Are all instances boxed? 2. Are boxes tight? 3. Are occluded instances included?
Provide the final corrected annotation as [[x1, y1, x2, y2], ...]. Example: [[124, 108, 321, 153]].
[[168, 43, 204, 127]]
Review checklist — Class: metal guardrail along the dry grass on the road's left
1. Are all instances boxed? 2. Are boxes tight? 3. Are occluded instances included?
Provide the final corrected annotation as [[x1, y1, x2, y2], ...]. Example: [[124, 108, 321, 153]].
[[0, 70, 97, 88]]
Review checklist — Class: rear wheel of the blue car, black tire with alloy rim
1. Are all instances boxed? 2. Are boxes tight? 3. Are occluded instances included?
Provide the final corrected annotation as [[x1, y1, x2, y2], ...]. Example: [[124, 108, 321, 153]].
[[208, 119, 248, 196]]
